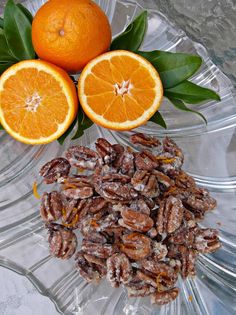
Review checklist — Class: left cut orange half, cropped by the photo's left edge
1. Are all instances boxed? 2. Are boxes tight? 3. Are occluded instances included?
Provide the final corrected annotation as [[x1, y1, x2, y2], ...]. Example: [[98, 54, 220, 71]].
[[0, 60, 78, 144]]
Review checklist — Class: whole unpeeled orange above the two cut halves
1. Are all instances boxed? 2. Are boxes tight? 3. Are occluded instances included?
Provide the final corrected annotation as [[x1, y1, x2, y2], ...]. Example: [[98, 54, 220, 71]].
[[32, 0, 111, 72]]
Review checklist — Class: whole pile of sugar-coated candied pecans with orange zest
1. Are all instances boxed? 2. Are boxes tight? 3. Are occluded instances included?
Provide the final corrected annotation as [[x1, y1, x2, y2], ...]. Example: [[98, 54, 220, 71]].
[[40, 134, 221, 305]]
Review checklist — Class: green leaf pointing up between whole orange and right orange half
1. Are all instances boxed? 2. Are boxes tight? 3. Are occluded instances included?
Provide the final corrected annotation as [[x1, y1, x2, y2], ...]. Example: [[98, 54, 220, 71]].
[[110, 11, 147, 51]]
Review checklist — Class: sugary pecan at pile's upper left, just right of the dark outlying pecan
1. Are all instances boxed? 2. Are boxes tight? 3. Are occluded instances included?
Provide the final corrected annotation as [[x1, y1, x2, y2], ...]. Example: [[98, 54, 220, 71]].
[[65, 146, 99, 170]]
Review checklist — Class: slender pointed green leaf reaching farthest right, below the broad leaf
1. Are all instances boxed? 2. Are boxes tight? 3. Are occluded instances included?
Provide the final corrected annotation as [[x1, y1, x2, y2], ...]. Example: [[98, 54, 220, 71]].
[[164, 81, 220, 104]]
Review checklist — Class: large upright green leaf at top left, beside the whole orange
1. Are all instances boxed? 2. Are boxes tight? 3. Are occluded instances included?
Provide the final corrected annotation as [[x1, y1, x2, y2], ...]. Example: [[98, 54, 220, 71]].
[[4, 0, 35, 60]]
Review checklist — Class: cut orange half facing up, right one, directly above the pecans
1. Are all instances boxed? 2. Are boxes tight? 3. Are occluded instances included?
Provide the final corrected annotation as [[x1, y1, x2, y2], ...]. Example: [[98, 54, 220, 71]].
[[78, 50, 163, 130]]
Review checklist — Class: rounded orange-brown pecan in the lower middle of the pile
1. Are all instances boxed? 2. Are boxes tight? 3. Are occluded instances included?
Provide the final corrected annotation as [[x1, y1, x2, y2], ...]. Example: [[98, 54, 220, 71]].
[[120, 232, 151, 260]]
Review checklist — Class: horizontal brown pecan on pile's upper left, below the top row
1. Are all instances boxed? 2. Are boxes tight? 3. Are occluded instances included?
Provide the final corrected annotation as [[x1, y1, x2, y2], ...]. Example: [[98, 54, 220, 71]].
[[62, 176, 93, 199]]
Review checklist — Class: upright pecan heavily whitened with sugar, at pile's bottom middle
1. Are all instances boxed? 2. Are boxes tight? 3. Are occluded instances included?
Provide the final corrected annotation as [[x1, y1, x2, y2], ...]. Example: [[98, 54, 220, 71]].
[[107, 253, 132, 288]]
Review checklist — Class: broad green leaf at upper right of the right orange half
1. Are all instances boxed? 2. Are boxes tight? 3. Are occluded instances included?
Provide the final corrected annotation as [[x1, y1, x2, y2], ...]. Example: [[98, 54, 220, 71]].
[[137, 50, 202, 89]]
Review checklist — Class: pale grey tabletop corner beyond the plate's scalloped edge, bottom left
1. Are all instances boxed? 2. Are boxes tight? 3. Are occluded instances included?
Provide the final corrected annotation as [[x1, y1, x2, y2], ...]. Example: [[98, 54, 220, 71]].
[[0, 267, 59, 315]]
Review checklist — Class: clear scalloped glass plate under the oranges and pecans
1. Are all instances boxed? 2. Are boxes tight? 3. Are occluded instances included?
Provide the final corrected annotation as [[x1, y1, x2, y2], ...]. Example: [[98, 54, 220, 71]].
[[0, 0, 236, 315]]
